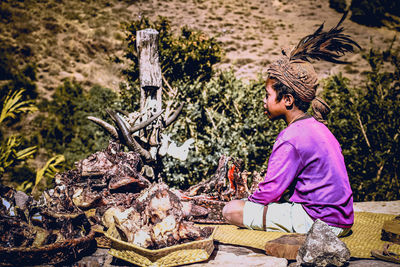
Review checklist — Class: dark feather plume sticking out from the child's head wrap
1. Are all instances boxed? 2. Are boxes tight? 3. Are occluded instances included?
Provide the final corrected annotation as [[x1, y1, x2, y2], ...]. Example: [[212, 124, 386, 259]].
[[290, 12, 361, 64]]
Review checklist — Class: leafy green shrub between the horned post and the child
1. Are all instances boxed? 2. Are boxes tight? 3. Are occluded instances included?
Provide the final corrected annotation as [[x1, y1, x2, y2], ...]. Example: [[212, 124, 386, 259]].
[[163, 72, 283, 188]]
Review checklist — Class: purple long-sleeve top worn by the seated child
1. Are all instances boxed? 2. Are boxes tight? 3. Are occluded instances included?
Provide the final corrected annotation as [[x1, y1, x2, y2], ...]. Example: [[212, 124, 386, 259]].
[[248, 117, 354, 228]]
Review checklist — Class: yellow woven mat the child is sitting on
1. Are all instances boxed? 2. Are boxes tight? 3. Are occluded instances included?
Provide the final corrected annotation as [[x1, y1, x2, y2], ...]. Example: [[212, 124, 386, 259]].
[[214, 212, 400, 258]]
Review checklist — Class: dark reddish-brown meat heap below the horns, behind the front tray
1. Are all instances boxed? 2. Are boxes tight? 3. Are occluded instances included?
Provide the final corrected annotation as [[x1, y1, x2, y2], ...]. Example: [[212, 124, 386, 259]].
[[51, 141, 150, 214]]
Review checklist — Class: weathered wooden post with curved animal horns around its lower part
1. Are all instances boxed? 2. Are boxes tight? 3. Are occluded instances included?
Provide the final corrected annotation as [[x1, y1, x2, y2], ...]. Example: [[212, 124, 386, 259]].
[[88, 29, 185, 180]]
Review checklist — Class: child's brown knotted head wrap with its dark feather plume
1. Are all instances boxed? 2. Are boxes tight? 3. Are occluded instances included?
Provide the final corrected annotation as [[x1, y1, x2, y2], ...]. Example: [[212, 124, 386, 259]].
[[267, 12, 360, 122]]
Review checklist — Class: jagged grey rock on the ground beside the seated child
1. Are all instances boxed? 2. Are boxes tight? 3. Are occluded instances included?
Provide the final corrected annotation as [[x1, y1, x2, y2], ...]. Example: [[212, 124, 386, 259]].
[[296, 220, 350, 267]]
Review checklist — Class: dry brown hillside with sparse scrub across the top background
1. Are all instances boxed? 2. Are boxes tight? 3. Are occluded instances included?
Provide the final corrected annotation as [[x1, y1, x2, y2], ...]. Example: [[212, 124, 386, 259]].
[[0, 0, 396, 96]]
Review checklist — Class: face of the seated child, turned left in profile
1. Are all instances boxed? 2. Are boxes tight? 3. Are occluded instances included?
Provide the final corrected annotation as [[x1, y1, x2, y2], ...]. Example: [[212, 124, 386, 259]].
[[263, 79, 286, 120]]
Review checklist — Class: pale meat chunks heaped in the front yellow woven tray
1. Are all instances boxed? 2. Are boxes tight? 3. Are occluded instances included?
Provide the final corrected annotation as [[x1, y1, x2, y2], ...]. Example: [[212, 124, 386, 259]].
[[103, 183, 211, 249]]
